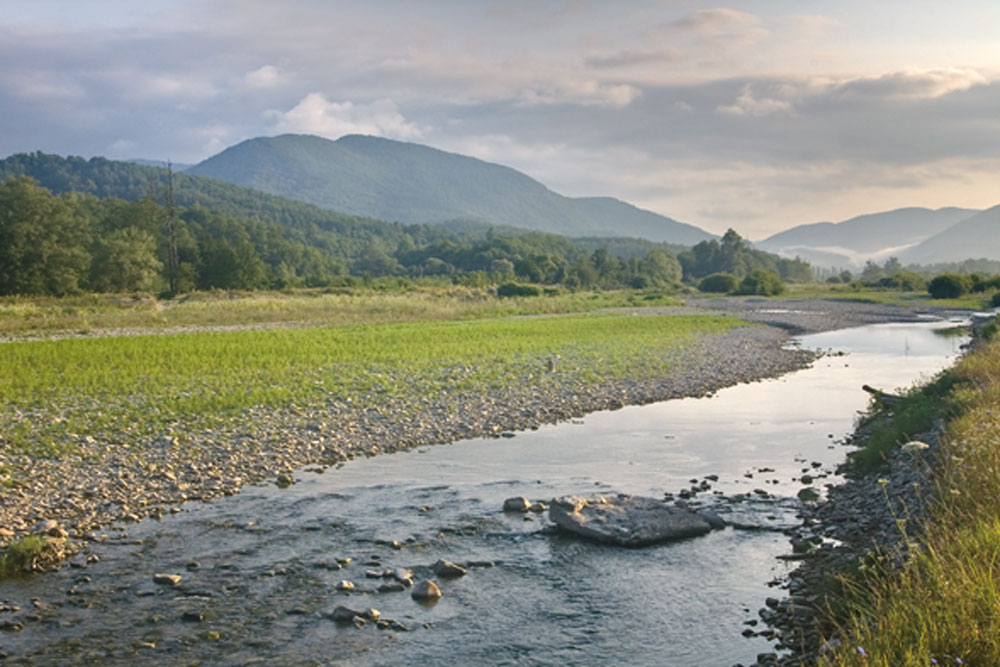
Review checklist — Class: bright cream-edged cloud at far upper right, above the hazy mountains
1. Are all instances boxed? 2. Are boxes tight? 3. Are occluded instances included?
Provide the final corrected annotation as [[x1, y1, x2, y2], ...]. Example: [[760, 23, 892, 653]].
[[836, 67, 987, 99]]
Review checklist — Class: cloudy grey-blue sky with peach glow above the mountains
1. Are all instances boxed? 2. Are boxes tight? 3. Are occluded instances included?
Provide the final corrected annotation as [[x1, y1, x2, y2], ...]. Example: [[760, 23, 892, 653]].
[[0, 0, 1000, 240]]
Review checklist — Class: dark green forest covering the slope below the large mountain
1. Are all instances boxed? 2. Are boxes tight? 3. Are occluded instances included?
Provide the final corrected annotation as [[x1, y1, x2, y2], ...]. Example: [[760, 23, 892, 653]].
[[0, 153, 812, 295]]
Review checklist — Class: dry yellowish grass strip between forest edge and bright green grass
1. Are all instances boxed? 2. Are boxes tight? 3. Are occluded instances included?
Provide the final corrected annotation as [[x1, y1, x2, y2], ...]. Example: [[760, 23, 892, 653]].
[[0, 286, 679, 338]]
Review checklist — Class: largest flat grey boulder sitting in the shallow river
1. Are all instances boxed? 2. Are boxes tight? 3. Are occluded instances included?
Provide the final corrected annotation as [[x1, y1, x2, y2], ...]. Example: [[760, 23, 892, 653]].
[[549, 494, 712, 547]]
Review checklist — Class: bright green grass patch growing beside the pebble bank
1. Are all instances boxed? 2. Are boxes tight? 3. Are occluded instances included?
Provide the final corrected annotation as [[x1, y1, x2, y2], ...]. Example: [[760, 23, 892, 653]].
[[0, 312, 740, 456]]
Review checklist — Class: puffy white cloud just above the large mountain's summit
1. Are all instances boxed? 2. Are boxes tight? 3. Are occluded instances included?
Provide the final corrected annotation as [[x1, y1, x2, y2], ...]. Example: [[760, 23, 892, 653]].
[[265, 92, 424, 139]]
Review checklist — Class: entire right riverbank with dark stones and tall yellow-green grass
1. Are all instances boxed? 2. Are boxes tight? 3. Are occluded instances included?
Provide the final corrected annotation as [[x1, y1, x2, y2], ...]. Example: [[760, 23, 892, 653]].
[[758, 316, 1000, 666]]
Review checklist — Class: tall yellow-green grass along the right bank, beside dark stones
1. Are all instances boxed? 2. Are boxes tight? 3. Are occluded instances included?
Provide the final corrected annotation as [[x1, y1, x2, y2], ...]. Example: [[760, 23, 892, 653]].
[[823, 320, 1000, 667]]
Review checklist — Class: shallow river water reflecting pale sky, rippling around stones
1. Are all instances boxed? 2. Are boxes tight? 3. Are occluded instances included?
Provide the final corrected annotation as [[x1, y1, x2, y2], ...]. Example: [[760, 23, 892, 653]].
[[0, 322, 963, 665]]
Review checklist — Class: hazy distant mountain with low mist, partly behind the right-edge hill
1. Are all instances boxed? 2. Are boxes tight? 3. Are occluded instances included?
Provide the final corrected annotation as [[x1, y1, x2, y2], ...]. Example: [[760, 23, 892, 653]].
[[755, 207, 978, 266]]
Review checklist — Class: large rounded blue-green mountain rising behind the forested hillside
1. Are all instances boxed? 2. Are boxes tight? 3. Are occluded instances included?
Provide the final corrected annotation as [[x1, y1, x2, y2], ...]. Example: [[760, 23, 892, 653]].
[[185, 134, 713, 245]]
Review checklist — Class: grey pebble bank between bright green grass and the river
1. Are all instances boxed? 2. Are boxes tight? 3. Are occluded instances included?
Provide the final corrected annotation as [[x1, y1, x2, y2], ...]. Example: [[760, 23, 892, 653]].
[[0, 300, 952, 572]]
